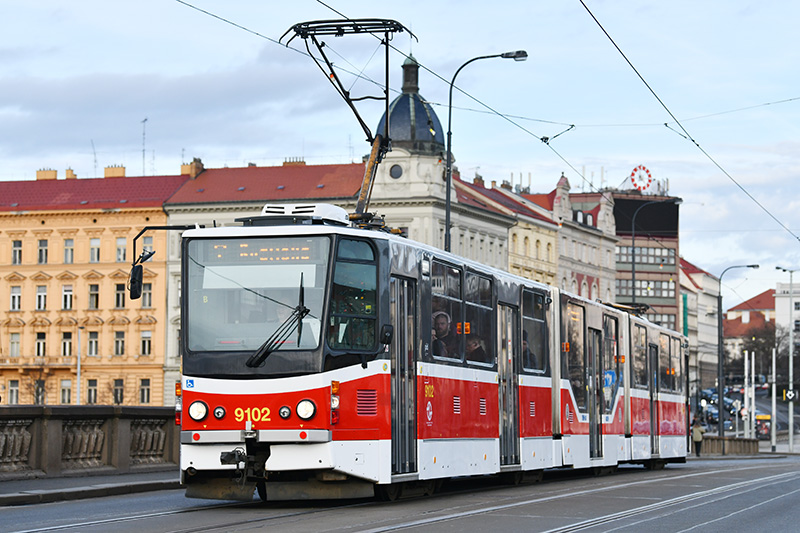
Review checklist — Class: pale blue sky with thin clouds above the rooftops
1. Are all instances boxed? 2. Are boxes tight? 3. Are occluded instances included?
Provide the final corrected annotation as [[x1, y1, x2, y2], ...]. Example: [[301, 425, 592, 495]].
[[0, 0, 800, 308]]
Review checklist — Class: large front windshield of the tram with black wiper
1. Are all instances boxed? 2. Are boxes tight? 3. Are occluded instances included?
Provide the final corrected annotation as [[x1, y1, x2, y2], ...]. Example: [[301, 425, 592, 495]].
[[183, 236, 331, 371]]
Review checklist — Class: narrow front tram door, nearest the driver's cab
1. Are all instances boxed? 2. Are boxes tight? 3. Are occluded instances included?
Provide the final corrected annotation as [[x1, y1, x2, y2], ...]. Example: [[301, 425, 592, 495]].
[[389, 277, 417, 474]]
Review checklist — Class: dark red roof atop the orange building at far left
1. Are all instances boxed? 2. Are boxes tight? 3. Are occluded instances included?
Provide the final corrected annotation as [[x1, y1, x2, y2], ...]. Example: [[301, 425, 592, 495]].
[[0, 172, 189, 212]]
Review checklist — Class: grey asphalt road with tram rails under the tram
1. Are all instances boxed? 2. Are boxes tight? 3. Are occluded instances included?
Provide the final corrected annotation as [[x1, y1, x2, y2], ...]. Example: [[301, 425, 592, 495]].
[[0, 456, 800, 533]]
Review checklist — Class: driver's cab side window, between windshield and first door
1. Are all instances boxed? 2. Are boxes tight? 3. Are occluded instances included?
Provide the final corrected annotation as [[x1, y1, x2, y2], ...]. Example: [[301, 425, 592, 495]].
[[328, 239, 377, 350]]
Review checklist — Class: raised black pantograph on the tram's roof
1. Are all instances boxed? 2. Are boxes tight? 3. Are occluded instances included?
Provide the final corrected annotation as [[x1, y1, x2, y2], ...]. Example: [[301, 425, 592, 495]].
[[280, 19, 417, 218]]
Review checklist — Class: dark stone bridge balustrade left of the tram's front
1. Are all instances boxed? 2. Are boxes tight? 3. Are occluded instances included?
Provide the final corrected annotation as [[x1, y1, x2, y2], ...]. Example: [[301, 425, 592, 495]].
[[0, 406, 180, 479]]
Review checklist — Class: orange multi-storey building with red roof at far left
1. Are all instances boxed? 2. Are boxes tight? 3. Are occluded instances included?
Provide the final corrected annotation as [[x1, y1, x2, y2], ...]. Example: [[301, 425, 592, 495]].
[[0, 167, 188, 405]]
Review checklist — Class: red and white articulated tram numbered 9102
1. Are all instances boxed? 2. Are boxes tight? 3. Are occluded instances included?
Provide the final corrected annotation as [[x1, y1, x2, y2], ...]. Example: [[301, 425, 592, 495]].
[[136, 204, 687, 500]]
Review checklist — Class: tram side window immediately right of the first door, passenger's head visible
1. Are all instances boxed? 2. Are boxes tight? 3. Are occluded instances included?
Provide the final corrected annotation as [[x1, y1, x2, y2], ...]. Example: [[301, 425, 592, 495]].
[[431, 261, 464, 361]]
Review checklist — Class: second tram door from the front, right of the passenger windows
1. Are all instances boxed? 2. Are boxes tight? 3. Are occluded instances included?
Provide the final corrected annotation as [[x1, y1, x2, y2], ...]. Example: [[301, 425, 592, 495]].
[[497, 304, 520, 465]]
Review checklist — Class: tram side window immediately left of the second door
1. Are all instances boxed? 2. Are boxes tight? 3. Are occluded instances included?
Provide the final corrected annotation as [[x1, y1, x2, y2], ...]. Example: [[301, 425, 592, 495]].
[[462, 272, 495, 365]]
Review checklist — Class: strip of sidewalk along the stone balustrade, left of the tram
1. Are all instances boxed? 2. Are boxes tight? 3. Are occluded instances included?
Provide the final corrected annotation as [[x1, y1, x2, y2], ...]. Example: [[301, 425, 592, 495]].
[[0, 467, 180, 507]]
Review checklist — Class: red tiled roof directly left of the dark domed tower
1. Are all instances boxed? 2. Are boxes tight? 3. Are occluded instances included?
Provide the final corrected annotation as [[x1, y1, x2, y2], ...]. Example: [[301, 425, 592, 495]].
[[167, 163, 364, 205]]
